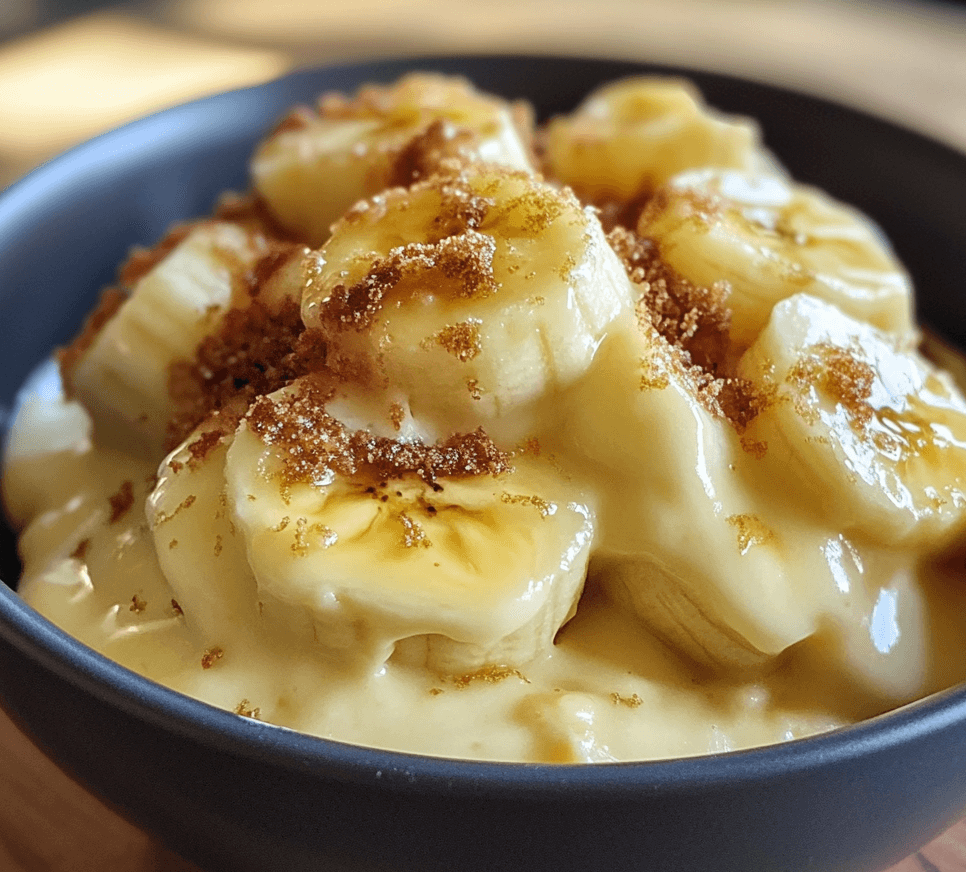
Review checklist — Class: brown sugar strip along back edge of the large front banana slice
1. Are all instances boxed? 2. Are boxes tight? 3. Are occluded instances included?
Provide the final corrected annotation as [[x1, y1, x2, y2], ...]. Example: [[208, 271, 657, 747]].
[[246, 379, 510, 484]]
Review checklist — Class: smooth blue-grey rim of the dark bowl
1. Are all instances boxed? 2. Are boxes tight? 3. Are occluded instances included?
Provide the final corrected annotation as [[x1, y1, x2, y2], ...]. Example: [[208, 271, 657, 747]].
[[0, 53, 966, 801]]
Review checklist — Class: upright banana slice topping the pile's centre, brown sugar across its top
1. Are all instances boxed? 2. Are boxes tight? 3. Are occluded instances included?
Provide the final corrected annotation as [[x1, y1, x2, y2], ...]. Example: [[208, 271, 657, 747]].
[[302, 168, 633, 433]]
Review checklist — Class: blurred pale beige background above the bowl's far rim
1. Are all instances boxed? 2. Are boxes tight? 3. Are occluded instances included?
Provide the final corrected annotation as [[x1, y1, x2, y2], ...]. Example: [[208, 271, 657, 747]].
[[0, 0, 966, 188]]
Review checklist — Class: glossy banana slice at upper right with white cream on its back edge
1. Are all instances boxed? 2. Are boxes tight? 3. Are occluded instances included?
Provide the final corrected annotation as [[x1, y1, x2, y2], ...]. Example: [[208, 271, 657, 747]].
[[637, 169, 916, 350]]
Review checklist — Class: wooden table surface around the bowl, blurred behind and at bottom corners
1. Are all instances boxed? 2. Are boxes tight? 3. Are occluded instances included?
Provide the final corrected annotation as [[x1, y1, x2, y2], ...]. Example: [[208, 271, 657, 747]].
[[0, 0, 966, 872]]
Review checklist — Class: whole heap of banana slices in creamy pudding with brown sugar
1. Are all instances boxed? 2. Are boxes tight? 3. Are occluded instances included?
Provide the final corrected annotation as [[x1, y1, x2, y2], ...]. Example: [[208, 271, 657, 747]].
[[3, 73, 966, 762]]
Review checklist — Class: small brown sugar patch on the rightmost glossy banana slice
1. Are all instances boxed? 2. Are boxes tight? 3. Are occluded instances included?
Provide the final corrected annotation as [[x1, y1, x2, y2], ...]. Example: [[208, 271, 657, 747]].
[[786, 343, 875, 431]]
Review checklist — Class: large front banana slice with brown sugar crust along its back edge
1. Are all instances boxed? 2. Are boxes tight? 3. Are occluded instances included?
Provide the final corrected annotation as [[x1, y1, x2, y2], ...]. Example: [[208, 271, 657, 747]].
[[225, 380, 594, 674]]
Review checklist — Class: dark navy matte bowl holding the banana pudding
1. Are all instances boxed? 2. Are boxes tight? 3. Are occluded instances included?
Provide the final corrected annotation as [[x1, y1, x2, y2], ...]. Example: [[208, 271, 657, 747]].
[[0, 56, 966, 872]]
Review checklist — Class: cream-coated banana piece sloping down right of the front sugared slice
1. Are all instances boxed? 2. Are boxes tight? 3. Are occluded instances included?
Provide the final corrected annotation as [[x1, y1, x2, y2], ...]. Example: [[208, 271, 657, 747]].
[[568, 316, 861, 669]]
